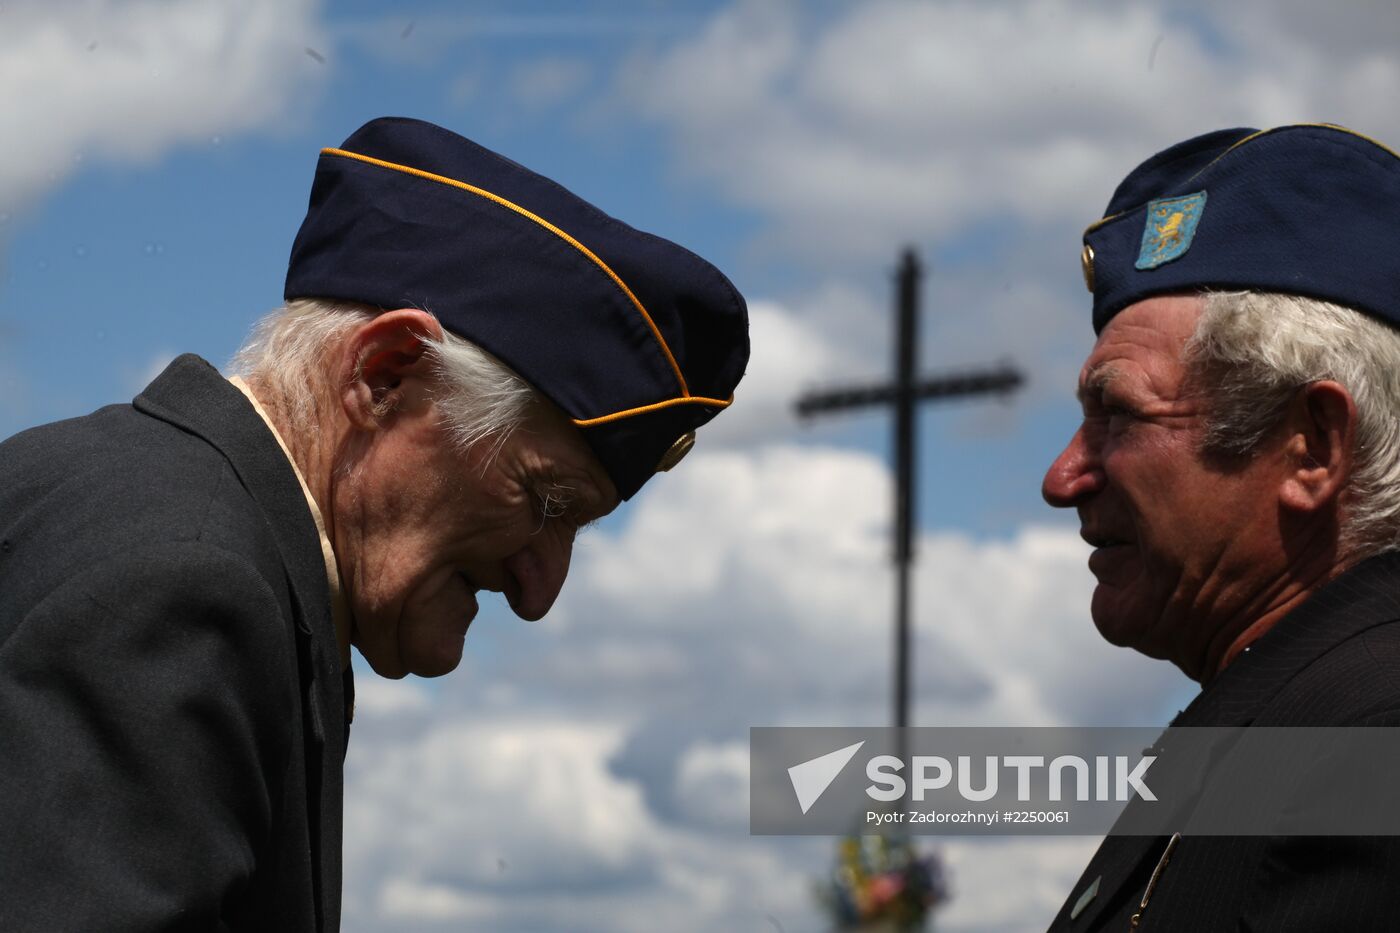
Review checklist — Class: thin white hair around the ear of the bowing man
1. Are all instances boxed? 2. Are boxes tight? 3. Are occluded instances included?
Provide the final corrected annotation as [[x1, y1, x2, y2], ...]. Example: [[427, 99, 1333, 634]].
[[230, 298, 538, 451]]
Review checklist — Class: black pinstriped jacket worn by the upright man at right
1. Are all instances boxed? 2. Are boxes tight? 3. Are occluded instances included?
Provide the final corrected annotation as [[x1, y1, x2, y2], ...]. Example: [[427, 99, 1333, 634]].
[[1050, 553, 1400, 933]]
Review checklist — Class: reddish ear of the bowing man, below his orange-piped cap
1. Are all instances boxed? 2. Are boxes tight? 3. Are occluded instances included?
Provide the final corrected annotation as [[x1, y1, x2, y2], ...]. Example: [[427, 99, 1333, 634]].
[[339, 308, 442, 430]]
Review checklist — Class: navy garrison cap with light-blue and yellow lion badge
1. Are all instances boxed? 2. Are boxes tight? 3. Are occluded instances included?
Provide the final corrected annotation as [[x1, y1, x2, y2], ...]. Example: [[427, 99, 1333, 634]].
[[1082, 123, 1400, 332]]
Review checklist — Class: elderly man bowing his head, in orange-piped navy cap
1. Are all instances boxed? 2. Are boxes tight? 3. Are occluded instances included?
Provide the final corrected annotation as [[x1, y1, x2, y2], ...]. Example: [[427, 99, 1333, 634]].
[[0, 119, 748, 930]]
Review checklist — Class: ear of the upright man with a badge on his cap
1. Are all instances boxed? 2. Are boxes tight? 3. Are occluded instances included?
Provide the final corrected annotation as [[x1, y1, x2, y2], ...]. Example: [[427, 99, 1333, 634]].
[[1280, 380, 1357, 511]]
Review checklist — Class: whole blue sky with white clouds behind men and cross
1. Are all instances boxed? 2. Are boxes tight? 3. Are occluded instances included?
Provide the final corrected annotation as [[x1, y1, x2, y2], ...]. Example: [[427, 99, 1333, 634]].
[[0, 0, 1400, 933]]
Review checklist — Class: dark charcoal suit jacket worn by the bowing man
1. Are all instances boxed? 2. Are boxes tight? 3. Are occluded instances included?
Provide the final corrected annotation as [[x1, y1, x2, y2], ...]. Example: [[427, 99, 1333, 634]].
[[0, 356, 346, 930]]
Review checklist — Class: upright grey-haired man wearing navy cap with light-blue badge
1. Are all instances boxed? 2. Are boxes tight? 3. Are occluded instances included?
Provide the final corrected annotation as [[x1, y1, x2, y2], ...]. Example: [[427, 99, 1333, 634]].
[[1043, 125, 1400, 932]]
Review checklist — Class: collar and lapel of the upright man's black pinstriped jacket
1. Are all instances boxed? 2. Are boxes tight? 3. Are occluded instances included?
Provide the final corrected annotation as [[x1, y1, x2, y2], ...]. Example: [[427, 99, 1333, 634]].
[[1051, 553, 1400, 930]]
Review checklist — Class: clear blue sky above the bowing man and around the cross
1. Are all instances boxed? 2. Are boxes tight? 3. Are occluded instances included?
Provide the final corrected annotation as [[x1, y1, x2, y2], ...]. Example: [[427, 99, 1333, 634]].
[[0, 3, 1078, 534]]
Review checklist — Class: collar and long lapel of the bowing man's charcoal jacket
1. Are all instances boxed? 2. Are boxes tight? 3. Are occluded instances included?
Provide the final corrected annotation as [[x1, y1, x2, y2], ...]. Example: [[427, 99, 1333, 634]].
[[133, 354, 346, 930]]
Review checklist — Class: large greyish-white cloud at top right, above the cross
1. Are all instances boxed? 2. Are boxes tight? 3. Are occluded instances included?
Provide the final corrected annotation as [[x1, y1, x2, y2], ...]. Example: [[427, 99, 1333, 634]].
[[619, 0, 1400, 262]]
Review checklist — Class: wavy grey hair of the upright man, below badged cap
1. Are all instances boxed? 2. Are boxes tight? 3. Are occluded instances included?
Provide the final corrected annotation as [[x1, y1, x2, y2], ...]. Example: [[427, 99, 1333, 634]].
[[1184, 291, 1400, 559]]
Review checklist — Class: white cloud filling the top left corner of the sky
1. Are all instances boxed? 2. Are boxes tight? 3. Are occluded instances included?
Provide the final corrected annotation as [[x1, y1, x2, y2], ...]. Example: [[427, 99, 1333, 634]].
[[0, 0, 323, 210]]
